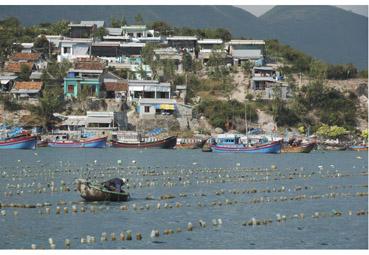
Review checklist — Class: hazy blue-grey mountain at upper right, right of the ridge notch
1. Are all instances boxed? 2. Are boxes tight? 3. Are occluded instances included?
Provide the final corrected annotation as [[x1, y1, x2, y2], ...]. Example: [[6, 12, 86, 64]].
[[260, 6, 368, 68]]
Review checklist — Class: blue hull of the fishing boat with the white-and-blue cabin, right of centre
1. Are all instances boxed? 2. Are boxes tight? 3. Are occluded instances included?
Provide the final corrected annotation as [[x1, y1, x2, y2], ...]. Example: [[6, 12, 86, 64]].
[[211, 142, 282, 153]]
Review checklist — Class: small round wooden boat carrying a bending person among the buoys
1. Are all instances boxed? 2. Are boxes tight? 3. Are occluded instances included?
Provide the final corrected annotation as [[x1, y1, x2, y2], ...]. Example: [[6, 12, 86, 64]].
[[77, 179, 130, 202]]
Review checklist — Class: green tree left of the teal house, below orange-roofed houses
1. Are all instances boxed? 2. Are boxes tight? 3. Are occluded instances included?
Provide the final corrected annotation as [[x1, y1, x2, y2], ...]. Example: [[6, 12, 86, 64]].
[[30, 87, 64, 131]]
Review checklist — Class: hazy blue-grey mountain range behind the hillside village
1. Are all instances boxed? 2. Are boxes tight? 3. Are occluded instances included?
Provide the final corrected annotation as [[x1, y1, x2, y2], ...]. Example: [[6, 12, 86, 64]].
[[0, 6, 368, 69]]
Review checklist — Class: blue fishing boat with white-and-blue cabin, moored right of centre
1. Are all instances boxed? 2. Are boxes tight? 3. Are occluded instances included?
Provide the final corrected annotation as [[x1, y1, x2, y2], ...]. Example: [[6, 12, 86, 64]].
[[210, 134, 282, 153]]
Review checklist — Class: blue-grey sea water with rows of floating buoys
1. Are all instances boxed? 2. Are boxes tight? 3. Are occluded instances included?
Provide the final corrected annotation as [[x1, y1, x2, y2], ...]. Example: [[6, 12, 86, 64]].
[[0, 148, 368, 249]]
